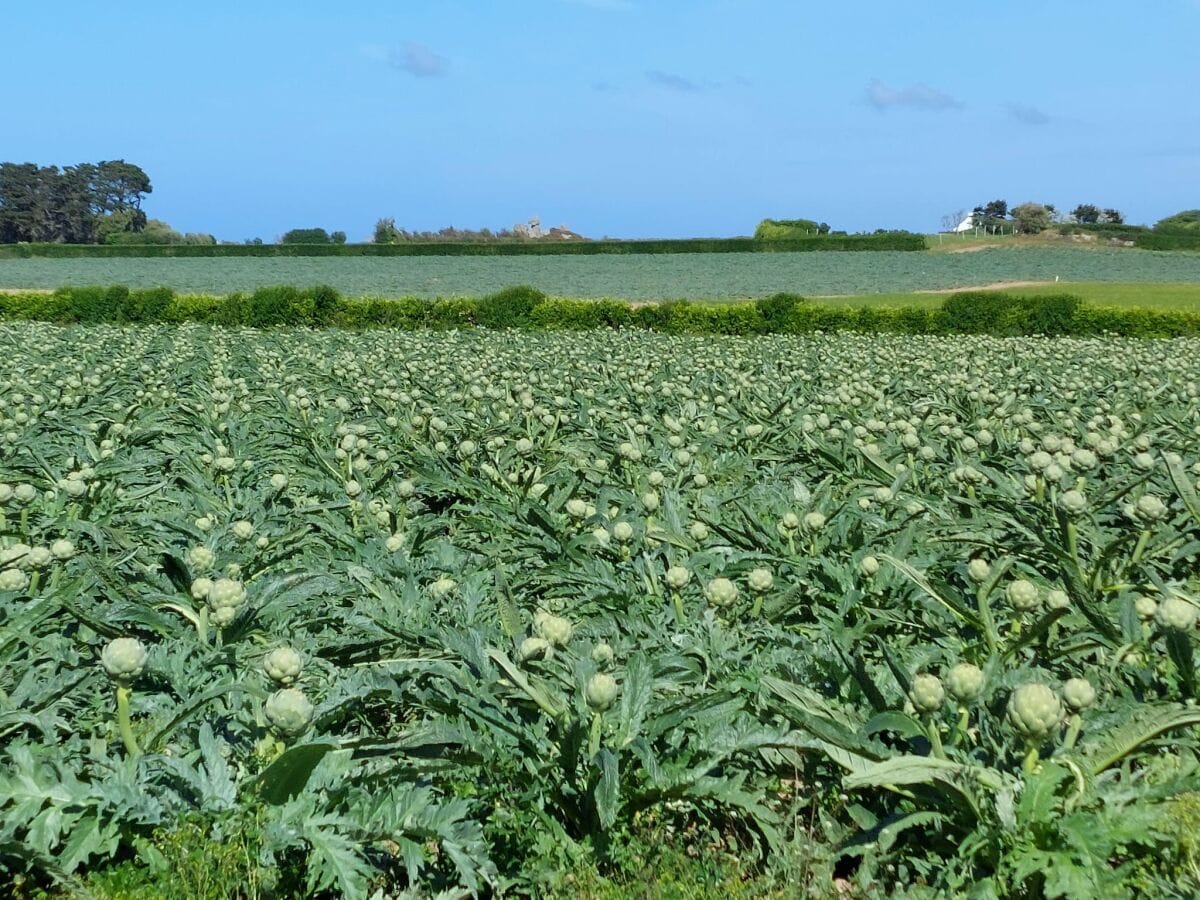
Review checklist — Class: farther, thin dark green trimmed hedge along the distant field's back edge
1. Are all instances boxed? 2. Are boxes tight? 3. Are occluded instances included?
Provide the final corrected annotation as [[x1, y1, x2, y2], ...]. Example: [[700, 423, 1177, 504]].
[[0, 232, 925, 259]]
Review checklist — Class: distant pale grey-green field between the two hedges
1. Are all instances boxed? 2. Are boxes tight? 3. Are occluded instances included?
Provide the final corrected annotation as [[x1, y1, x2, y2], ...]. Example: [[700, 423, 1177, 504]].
[[0, 247, 1200, 300]]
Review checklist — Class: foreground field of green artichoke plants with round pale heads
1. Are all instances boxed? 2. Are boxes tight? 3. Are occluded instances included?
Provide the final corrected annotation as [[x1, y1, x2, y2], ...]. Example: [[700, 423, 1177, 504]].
[[0, 324, 1200, 898]]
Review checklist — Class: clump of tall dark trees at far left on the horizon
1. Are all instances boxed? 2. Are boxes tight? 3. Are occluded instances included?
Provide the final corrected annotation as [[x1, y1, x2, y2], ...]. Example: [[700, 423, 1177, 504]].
[[0, 160, 154, 244]]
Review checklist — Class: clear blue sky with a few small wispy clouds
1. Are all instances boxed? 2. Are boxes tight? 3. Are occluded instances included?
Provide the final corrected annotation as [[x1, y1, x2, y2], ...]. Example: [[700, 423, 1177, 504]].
[[0, 0, 1200, 240]]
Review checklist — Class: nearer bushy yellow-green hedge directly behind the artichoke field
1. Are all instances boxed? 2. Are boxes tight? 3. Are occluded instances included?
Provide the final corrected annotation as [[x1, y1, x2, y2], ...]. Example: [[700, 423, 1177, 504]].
[[0, 286, 1200, 337]]
